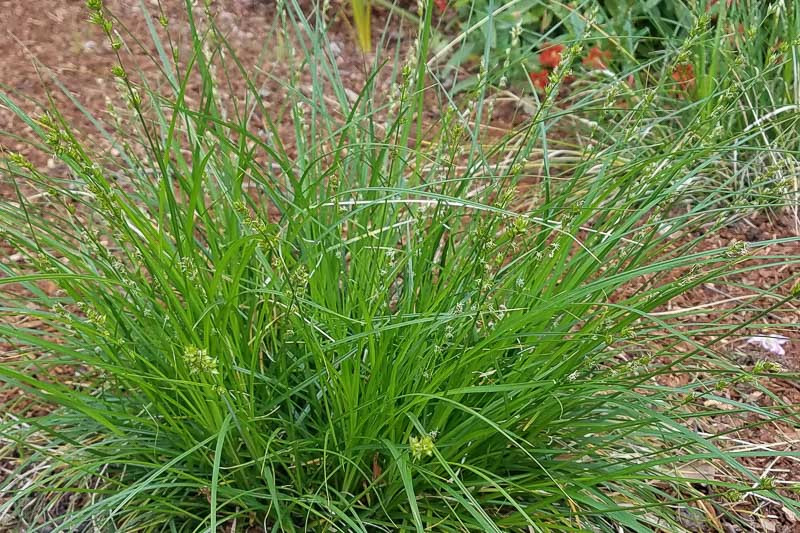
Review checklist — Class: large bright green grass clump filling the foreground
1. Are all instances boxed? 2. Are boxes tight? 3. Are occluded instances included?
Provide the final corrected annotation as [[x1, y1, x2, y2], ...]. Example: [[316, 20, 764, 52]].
[[0, 2, 794, 531]]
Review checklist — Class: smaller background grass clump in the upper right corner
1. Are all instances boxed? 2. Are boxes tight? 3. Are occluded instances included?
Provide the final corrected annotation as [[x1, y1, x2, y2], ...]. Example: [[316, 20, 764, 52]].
[[679, 2, 800, 205]]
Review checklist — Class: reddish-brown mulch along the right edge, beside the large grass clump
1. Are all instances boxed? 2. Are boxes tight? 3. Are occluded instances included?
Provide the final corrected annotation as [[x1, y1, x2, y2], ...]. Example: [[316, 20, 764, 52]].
[[663, 212, 800, 532]]
